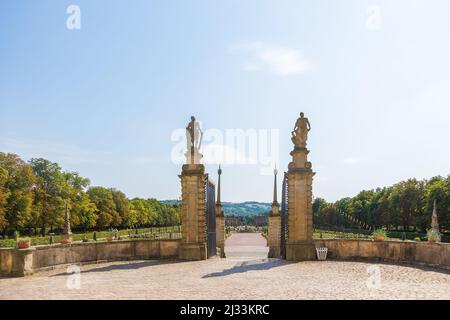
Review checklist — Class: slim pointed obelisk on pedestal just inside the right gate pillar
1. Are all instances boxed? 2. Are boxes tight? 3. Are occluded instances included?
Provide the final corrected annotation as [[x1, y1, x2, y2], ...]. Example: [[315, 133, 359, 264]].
[[268, 169, 281, 258]]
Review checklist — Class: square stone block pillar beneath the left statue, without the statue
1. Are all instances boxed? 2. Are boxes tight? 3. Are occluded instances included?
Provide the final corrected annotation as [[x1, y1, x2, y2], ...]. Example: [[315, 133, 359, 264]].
[[179, 164, 207, 260]]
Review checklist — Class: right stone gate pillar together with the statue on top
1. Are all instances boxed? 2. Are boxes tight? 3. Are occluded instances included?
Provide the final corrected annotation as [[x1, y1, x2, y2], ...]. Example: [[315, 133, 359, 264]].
[[286, 112, 316, 261]]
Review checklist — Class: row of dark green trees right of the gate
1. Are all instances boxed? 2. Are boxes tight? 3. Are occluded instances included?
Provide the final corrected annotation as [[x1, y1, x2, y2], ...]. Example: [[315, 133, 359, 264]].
[[313, 175, 450, 232]]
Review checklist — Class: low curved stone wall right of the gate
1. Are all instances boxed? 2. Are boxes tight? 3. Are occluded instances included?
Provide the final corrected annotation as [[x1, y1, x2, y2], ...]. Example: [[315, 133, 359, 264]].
[[315, 239, 450, 269]]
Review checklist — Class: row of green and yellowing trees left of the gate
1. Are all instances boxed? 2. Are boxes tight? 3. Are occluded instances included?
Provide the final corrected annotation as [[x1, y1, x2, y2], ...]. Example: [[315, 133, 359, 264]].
[[0, 152, 180, 234]]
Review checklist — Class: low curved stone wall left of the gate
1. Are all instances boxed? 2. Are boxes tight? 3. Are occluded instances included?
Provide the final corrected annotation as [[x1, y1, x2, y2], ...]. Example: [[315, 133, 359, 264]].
[[0, 240, 180, 277]]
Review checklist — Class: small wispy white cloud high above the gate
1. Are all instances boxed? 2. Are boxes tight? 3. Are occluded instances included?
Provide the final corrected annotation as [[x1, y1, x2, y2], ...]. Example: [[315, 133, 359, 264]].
[[230, 42, 311, 77]]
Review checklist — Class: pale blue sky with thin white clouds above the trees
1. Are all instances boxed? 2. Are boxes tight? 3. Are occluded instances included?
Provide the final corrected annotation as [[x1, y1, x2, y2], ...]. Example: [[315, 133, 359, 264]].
[[0, 0, 450, 202]]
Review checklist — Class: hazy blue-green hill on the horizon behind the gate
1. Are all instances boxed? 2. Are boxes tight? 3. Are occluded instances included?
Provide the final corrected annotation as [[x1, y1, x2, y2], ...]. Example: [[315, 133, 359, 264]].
[[161, 200, 271, 217]]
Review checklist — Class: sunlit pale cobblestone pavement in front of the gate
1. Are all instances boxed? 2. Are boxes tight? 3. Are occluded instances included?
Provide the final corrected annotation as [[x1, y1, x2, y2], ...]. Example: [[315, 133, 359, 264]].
[[0, 232, 450, 300]]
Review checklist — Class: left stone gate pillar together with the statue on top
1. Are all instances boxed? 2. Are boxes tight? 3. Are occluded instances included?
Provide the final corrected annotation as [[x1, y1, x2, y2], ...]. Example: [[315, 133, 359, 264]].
[[179, 117, 207, 260]]
